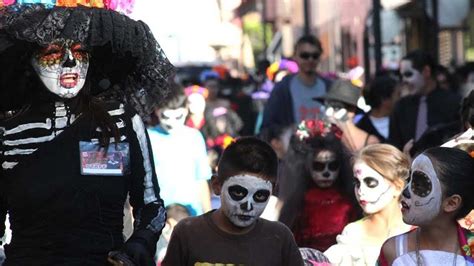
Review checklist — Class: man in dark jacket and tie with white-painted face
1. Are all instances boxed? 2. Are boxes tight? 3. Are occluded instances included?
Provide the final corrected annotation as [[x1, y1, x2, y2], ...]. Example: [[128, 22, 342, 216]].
[[389, 50, 460, 152]]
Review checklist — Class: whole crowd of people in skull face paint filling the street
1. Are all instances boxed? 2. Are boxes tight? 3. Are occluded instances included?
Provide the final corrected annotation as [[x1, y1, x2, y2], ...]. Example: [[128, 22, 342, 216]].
[[0, 1, 474, 266]]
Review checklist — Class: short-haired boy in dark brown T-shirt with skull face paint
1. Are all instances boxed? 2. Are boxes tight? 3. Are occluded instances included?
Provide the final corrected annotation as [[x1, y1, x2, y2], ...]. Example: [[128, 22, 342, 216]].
[[162, 137, 303, 266]]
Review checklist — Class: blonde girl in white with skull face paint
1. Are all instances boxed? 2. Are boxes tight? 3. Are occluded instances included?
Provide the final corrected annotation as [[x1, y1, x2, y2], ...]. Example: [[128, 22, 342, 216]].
[[324, 144, 410, 265]]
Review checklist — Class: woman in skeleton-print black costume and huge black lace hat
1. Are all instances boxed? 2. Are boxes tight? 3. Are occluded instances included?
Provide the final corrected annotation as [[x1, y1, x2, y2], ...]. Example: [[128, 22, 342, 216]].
[[0, 0, 173, 265]]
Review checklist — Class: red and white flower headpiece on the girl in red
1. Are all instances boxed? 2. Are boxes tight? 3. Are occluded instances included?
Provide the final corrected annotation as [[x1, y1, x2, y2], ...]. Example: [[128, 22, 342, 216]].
[[296, 119, 342, 140]]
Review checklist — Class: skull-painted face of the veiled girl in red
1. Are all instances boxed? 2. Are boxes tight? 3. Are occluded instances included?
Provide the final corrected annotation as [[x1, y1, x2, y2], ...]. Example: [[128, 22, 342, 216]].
[[311, 150, 339, 188]]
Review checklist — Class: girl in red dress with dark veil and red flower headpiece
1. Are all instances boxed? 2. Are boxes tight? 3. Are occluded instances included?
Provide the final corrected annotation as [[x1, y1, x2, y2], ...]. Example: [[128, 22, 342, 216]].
[[278, 120, 357, 251]]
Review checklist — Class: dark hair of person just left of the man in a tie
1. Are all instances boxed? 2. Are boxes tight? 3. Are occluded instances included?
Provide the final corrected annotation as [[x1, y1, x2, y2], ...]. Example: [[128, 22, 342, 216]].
[[362, 75, 398, 109]]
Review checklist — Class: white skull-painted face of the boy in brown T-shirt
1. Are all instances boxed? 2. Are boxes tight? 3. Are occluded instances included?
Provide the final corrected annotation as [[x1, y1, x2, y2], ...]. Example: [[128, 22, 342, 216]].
[[221, 175, 272, 227]]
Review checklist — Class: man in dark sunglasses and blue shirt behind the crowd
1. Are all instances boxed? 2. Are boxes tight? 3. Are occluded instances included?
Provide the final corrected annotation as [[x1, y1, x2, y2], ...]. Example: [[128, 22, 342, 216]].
[[262, 35, 330, 131]]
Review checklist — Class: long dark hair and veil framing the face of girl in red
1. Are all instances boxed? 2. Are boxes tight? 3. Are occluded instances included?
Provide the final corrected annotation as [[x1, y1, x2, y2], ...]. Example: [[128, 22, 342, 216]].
[[278, 133, 357, 228]]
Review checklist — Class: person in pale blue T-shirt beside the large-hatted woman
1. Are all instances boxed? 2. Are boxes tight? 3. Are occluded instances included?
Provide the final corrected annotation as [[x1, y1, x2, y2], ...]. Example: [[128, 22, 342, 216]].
[[148, 85, 212, 215]]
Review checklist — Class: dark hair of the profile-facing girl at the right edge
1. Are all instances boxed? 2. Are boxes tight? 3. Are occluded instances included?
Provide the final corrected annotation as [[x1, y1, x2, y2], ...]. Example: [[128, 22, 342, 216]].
[[423, 147, 474, 219]]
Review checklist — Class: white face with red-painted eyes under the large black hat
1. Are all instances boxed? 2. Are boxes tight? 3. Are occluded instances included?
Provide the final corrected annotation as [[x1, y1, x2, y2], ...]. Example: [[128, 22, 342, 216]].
[[31, 41, 89, 99]]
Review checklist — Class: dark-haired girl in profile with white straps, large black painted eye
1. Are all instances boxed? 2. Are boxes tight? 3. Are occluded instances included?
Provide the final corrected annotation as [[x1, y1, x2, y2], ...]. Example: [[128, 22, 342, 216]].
[[379, 147, 474, 266]]
